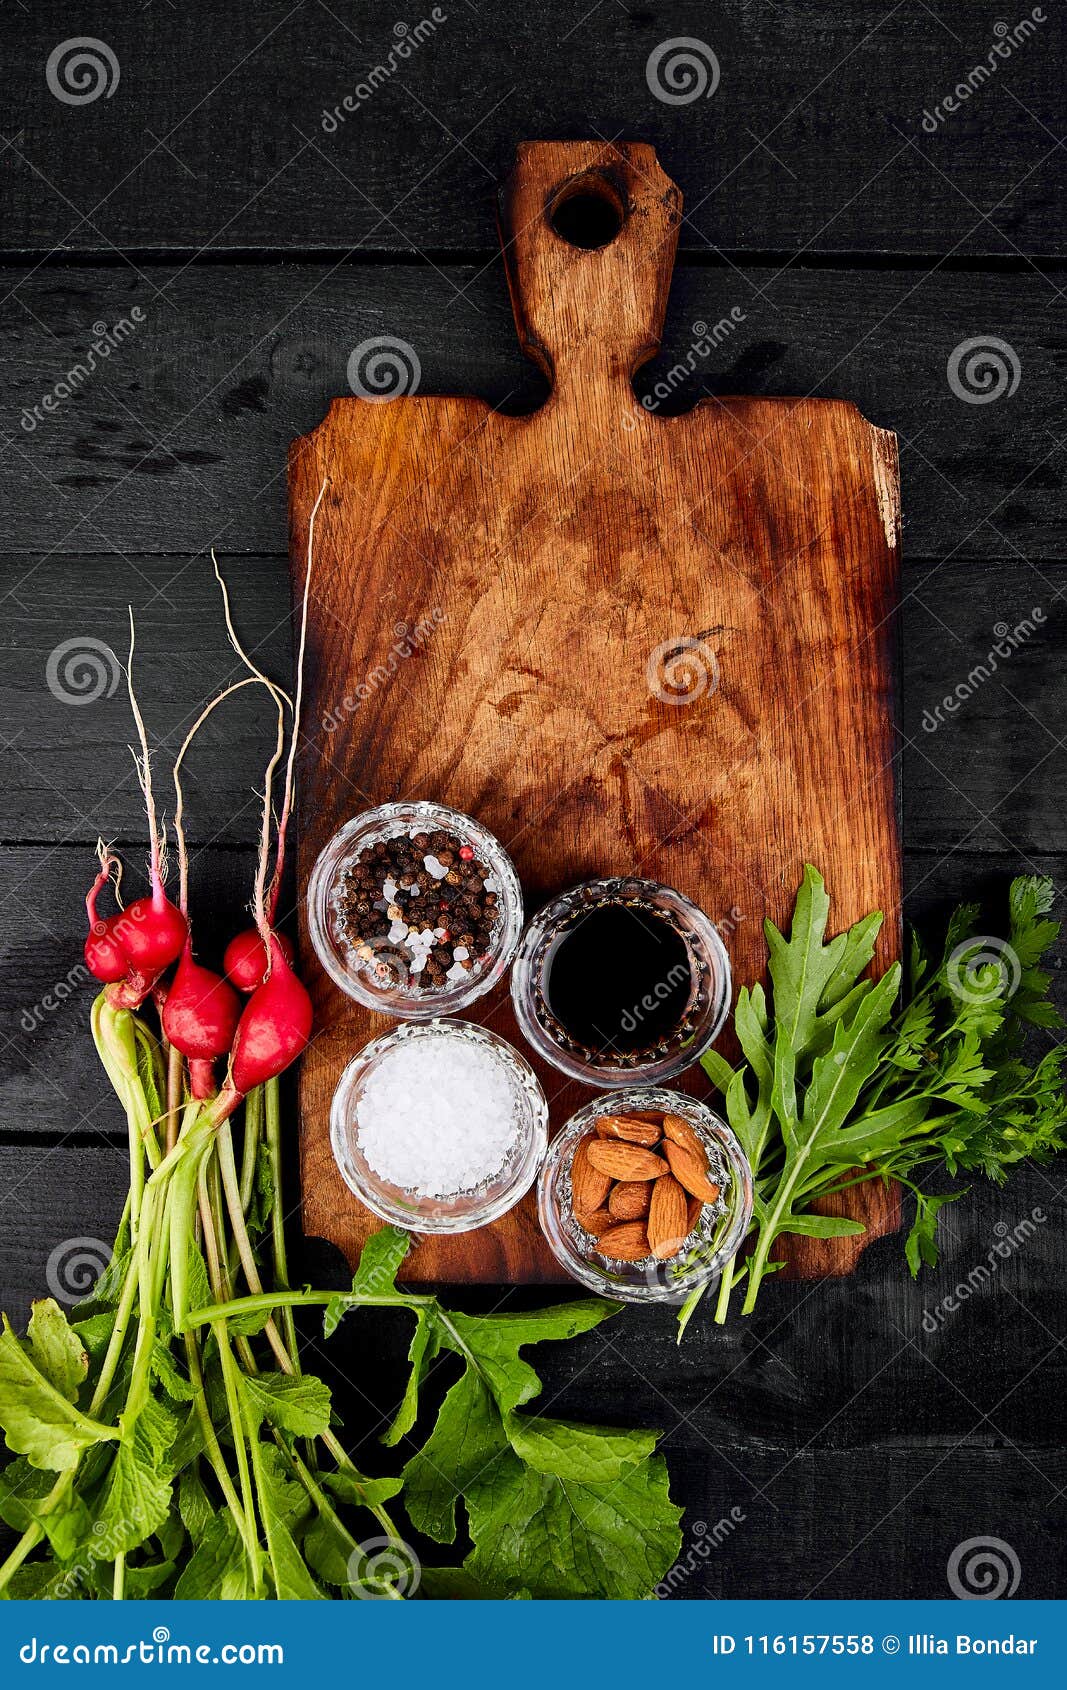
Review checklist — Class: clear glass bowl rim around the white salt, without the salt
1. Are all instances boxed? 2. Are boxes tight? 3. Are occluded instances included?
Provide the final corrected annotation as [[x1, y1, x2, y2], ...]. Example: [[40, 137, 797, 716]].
[[330, 1021, 548, 1232]]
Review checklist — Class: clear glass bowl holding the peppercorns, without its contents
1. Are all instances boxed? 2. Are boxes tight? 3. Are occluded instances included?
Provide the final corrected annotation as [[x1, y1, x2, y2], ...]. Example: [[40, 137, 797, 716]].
[[308, 801, 523, 1021]]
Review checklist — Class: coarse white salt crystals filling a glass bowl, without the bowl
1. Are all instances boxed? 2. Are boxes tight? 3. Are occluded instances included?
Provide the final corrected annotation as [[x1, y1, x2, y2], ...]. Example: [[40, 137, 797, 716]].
[[355, 1027, 524, 1197]]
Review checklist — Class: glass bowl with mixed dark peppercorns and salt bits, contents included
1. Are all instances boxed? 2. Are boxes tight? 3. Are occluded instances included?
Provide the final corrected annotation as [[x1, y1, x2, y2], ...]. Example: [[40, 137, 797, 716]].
[[308, 801, 523, 1021]]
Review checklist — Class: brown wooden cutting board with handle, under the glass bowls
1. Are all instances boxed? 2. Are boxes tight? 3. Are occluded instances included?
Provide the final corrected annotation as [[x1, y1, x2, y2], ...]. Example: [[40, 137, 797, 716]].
[[289, 142, 901, 1283]]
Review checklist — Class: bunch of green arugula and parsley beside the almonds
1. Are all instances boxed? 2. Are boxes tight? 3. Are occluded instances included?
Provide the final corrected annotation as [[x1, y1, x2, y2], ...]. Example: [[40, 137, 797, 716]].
[[680, 865, 1067, 1332]]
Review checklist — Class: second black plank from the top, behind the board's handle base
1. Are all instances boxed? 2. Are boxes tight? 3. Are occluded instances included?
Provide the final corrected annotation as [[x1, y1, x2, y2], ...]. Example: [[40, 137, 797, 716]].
[[0, 260, 1067, 558]]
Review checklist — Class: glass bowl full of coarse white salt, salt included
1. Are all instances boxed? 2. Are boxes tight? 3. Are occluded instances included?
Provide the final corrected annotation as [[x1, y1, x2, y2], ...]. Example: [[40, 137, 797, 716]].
[[330, 1019, 548, 1232]]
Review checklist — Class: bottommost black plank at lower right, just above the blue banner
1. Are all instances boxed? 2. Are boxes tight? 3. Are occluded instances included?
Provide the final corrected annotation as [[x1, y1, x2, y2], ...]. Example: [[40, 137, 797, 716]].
[[665, 1439, 1067, 1595]]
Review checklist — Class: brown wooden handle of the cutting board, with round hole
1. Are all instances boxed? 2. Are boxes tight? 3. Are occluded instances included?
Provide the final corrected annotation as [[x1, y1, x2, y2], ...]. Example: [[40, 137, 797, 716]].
[[499, 140, 681, 406]]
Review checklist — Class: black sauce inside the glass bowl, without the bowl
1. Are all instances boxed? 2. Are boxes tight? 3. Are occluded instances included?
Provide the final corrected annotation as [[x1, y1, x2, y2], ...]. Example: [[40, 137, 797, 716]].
[[541, 902, 693, 1055]]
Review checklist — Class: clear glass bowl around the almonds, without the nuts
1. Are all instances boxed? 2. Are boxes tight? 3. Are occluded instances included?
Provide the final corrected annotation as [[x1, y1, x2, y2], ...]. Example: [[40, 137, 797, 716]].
[[538, 1087, 752, 1303]]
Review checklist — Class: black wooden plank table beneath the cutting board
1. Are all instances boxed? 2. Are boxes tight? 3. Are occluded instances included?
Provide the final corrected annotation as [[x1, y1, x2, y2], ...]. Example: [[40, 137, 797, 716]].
[[0, 0, 1067, 1597]]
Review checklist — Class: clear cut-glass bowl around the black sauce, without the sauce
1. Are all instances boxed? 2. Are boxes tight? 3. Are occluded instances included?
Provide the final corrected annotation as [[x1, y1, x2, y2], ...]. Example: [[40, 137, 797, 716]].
[[511, 877, 730, 1085]]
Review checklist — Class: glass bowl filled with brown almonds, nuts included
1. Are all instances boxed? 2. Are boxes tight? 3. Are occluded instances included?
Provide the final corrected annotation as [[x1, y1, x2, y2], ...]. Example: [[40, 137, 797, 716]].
[[538, 1087, 752, 1303]]
